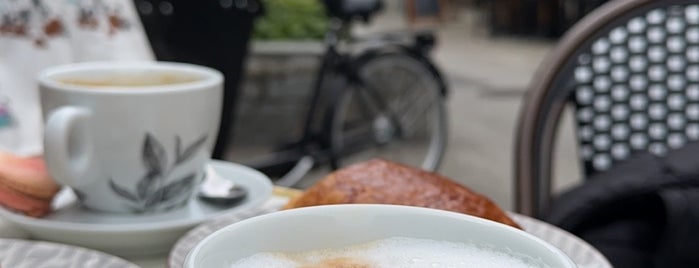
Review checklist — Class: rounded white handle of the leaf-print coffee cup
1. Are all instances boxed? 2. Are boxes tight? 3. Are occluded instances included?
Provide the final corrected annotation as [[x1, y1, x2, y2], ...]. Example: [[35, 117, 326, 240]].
[[44, 106, 96, 187]]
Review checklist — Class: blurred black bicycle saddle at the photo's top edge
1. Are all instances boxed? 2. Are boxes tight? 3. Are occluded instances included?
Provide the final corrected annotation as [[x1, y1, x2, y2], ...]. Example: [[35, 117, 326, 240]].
[[324, 0, 383, 22]]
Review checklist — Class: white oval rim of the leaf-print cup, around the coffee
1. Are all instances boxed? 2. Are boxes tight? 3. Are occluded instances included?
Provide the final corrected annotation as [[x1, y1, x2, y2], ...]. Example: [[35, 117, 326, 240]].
[[37, 61, 223, 95]]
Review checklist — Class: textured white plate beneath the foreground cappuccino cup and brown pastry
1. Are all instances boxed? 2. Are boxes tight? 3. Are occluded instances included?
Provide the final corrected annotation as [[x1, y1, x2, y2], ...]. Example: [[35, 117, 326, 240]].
[[168, 200, 612, 268]]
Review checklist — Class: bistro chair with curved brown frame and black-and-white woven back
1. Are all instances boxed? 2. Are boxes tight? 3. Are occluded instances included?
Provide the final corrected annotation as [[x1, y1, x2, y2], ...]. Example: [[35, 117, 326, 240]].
[[514, 0, 699, 217]]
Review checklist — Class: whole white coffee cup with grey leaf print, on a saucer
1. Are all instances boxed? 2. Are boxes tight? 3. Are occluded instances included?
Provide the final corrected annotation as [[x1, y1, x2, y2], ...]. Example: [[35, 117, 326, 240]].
[[38, 62, 223, 213]]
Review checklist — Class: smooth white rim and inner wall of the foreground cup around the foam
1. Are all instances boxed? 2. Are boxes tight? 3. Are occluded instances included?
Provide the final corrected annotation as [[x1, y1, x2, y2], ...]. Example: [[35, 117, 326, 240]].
[[185, 204, 576, 268]]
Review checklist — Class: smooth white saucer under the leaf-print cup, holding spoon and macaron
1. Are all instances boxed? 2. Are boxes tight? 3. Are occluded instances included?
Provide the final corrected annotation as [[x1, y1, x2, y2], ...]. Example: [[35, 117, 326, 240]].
[[0, 160, 272, 256]]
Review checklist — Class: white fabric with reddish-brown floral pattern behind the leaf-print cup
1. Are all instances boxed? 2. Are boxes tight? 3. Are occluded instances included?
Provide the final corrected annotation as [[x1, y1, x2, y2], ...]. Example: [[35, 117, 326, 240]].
[[0, 0, 154, 156]]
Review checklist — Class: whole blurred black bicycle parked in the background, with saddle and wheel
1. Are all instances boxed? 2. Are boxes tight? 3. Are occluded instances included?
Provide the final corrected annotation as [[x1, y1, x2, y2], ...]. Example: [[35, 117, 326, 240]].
[[243, 0, 447, 186]]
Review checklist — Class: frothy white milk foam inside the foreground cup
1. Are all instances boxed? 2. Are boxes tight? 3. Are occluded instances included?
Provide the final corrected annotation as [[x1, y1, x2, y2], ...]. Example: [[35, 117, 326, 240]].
[[231, 237, 549, 268]]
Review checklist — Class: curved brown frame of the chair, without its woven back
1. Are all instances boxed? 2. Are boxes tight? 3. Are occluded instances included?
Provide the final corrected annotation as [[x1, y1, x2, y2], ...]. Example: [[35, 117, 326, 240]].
[[514, 0, 699, 216]]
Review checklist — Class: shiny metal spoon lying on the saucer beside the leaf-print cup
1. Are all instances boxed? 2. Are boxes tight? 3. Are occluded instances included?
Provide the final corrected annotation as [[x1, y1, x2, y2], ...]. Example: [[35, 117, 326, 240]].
[[198, 166, 248, 206]]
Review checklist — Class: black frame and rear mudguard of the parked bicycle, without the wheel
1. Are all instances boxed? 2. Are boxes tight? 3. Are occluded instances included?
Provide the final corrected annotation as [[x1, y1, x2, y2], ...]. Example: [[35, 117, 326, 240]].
[[248, 15, 446, 186]]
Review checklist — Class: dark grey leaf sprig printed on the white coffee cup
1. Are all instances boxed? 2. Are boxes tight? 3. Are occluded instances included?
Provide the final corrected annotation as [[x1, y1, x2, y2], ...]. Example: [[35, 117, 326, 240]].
[[106, 133, 207, 213]]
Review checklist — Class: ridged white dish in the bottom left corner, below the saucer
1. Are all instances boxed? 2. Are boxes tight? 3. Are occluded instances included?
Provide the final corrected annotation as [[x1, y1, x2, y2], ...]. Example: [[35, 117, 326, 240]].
[[0, 239, 138, 268]]
